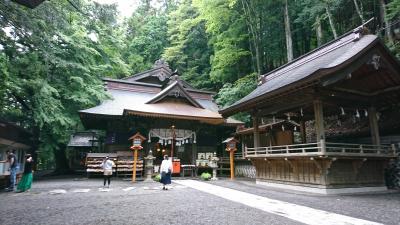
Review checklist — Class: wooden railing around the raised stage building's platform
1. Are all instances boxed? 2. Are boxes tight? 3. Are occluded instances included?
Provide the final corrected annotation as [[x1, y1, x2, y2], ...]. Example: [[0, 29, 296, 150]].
[[244, 140, 396, 158]]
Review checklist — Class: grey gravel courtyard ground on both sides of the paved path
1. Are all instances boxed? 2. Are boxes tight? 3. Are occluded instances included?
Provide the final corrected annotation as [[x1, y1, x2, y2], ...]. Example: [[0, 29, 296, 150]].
[[0, 178, 400, 225]]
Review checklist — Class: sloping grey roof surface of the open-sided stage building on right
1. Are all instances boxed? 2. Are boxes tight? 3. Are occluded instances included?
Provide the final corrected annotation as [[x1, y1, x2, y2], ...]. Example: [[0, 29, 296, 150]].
[[220, 32, 378, 115]]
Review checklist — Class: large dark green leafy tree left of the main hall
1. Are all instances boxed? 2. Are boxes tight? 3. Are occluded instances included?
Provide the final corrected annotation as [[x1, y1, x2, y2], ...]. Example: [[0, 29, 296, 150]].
[[0, 2, 120, 169]]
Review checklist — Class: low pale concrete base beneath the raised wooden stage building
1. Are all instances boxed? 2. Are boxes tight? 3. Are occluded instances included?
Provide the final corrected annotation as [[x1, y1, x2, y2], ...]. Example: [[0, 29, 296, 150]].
[[256, 180, 387, 195]]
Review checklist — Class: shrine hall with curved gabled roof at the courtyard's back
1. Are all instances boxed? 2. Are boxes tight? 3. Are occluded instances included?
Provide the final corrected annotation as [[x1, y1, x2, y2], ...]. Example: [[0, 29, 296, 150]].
[[79, 60, 242, 172]]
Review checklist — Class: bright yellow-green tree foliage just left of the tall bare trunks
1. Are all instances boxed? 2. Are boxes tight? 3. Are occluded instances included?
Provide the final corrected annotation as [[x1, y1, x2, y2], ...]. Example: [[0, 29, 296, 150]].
[[193, 0, 250, 84]]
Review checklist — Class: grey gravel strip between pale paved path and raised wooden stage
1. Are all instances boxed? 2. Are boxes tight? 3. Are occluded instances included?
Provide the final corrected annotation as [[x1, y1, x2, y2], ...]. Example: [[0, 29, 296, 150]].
[[209, 180, 400, 225]]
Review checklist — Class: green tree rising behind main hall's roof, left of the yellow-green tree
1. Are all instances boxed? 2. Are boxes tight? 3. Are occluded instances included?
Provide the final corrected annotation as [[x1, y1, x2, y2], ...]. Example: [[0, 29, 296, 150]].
[[163, 0, 215, 90]]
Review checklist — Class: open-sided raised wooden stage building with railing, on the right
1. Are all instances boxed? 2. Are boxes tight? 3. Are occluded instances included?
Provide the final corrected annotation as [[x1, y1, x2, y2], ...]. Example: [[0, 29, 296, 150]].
[[220, 27, 400, 194]]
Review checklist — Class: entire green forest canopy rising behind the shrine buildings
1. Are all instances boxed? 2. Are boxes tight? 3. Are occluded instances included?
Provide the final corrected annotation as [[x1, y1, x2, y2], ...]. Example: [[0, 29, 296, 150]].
[[0, 0, 400, 170]]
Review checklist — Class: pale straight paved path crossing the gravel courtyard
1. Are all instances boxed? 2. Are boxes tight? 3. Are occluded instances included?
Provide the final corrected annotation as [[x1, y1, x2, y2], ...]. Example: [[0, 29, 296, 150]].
[[174, 180, 383, 225]]
